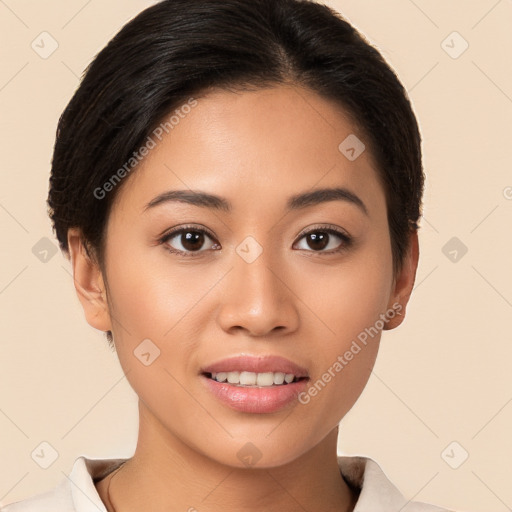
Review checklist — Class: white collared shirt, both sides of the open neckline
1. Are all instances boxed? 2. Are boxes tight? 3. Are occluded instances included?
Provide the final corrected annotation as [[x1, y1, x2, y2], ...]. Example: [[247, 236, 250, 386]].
[[0, 456, 450, 512]]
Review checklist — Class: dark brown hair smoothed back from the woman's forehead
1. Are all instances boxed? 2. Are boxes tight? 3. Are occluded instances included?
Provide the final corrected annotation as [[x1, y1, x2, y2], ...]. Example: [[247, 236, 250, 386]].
[[48, 0, 425, 341]]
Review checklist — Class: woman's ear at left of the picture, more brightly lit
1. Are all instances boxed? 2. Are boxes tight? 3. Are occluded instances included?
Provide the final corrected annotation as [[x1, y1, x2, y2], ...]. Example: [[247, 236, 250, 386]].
[[68, 228, 112, 331]]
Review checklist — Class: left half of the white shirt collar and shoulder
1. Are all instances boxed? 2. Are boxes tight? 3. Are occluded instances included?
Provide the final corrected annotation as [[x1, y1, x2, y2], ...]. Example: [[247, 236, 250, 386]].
[[0, 456, 126, 512]]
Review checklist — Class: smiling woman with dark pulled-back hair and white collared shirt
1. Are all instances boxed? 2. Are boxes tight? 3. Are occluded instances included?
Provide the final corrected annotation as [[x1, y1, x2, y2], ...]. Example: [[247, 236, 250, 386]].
[[3, 0, 452, 512]]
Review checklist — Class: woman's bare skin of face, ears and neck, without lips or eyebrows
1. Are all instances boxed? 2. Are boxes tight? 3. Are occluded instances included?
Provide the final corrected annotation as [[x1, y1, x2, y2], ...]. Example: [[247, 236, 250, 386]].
[[68, 86, 419, 512]]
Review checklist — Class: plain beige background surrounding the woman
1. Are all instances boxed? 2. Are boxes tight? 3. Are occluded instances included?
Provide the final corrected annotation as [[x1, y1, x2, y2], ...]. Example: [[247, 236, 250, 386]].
[[0, 0, 512, 512]]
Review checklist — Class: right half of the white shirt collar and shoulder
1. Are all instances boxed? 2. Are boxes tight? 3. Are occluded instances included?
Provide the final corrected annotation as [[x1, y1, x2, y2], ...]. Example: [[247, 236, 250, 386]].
[[338, 456, 454, 512]]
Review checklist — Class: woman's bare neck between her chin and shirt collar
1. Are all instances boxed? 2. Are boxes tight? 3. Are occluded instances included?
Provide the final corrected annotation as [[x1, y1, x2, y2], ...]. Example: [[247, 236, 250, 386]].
[[98, 402, 356, 512]]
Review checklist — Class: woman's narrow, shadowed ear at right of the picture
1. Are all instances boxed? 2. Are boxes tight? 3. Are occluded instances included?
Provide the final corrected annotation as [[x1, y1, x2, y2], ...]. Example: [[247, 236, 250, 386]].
[[383, 230, 420, 331]]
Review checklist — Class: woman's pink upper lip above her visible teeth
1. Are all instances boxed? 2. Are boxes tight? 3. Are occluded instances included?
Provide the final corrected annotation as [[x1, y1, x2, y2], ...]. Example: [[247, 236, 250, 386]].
[[201, 355, 308, 377]]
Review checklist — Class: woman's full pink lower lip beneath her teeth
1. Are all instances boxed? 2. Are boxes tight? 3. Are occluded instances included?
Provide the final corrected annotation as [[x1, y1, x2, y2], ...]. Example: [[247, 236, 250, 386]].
[[201, 375, 308, 413]]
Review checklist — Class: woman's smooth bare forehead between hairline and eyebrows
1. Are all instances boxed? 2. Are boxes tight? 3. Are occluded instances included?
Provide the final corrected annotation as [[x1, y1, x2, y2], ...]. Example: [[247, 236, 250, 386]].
[[110, 86, 385, 220]]
